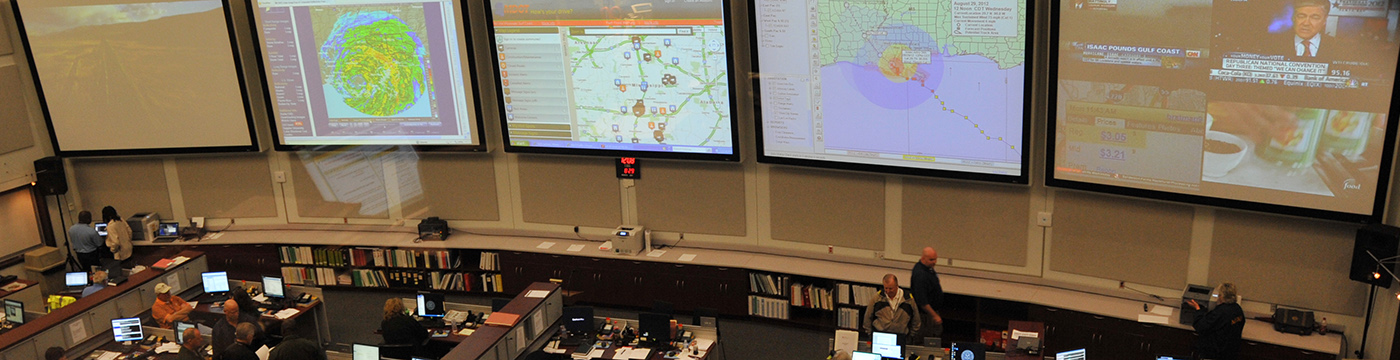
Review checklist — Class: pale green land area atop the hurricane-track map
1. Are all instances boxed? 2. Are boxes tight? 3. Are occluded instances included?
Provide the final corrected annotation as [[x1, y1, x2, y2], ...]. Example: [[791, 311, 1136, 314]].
[[816, 0, 1026, 69]]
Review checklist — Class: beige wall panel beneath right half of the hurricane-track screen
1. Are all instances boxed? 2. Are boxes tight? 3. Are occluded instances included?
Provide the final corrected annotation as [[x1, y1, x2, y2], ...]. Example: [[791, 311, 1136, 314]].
[[900, 178, 1030, 266]]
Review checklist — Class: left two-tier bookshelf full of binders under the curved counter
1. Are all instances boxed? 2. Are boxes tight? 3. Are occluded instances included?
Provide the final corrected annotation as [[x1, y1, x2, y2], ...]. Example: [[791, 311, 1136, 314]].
[[277, 245, 504, 293]]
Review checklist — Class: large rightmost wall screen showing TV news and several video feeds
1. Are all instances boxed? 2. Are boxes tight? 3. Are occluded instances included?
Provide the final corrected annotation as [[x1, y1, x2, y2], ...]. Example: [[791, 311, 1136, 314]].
[[1047, 0, 1400, 221]]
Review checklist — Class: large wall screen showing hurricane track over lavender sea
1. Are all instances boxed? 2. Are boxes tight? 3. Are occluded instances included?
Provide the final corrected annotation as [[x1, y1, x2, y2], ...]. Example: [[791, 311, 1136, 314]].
[[750, 0, 1033, 184]]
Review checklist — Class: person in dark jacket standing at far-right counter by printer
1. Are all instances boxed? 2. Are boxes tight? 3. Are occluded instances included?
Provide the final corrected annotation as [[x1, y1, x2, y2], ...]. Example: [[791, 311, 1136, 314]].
[[1187, 283, 1245, 360]]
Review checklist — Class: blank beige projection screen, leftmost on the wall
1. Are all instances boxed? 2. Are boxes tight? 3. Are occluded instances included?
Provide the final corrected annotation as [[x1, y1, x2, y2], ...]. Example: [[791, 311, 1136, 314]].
[[12, 0, 260, 157]]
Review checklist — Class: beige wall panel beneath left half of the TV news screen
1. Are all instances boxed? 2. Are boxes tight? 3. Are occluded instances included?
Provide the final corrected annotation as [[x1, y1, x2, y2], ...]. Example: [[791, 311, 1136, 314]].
[[1047, 191, 1196, 289]]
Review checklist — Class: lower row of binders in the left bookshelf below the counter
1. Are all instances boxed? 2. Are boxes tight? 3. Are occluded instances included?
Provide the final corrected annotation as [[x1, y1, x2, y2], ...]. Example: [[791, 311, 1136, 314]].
[[281, 266, 504, 293]]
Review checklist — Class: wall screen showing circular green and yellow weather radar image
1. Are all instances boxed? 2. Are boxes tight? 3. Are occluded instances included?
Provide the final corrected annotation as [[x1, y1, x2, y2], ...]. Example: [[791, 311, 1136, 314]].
[[251, 0, 486, 151]]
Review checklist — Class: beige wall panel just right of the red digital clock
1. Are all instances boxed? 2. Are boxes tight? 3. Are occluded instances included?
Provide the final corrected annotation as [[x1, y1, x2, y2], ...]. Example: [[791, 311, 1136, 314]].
[[637, 160, 748, 237]]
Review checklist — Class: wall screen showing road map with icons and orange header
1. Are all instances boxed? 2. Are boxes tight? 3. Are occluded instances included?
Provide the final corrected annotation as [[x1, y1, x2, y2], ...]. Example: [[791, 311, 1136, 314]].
[[486, 0, 739, 161]]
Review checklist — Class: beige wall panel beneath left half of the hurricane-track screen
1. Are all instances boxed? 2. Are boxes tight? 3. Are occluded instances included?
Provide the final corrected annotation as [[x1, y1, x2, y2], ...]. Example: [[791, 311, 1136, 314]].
[[769, 167, 885, 251]]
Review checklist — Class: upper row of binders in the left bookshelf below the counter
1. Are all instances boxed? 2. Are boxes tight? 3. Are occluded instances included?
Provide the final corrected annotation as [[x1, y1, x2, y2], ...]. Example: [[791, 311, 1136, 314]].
[[277, 247, 461, 269]]
